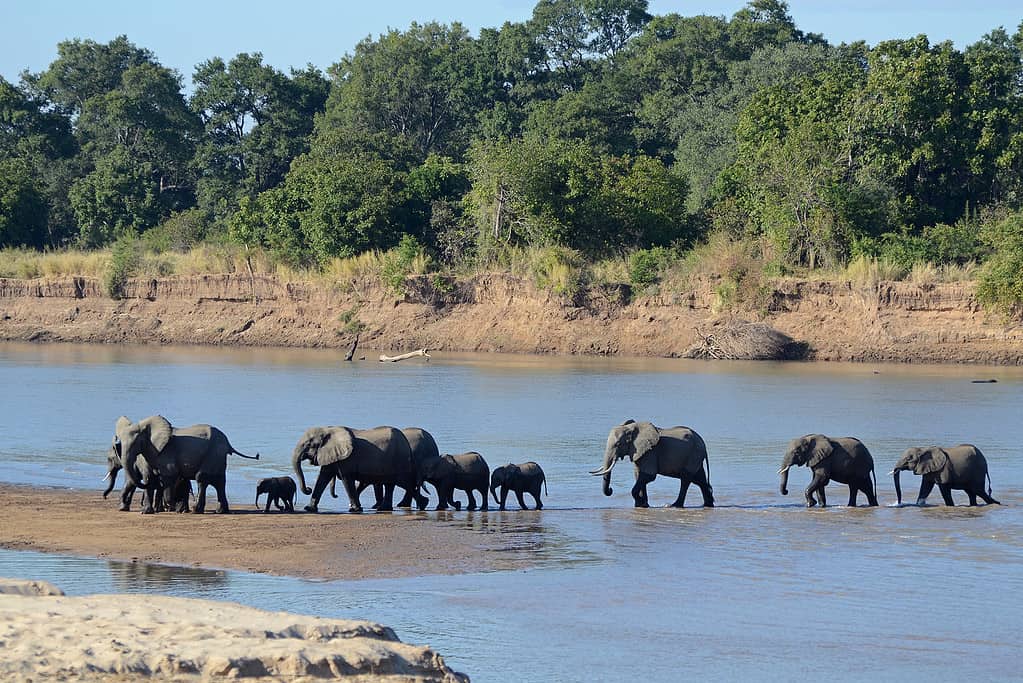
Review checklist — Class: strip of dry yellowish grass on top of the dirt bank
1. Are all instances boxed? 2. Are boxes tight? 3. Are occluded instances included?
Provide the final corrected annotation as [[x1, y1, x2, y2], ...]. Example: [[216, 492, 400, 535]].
[[0, 234, 1006, 311]]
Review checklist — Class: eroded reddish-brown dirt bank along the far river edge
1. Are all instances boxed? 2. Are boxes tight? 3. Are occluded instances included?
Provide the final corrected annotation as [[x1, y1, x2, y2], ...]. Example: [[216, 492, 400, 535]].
[[0, 274, 1023, 365]]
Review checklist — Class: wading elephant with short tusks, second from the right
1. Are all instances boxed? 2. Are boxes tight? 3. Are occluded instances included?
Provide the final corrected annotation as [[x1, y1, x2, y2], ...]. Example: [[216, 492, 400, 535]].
[[777, 434, 878, 507]]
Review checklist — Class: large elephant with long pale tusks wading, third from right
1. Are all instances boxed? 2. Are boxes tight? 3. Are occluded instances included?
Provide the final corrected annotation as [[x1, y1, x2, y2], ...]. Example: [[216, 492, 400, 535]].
[[590, 420, 714, 507]]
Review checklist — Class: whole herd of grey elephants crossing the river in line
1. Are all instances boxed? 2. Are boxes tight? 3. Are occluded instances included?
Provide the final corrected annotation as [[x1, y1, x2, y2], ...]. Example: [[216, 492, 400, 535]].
[[103, 415, 998, 513]]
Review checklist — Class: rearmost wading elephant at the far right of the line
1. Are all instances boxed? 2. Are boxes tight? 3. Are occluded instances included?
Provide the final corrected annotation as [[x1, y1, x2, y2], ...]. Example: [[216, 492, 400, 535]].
[[889, 444, 1002, 506]]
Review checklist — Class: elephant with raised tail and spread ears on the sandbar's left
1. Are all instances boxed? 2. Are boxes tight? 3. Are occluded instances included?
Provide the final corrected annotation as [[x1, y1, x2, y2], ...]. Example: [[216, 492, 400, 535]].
[[115, 415, 259, 514]]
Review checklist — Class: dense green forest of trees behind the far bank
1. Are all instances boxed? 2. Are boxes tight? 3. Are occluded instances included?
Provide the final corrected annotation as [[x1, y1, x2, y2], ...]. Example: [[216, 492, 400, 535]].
[[0, 0, 1023, 302]]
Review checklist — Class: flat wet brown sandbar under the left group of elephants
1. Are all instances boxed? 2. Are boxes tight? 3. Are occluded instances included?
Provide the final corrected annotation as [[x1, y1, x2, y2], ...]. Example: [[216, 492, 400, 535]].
[[0, 484, 530, 580]]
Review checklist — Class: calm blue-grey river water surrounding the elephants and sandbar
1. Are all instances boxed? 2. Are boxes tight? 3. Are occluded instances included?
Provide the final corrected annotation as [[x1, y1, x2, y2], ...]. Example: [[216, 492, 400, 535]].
[[0, 344, 1023, 681]]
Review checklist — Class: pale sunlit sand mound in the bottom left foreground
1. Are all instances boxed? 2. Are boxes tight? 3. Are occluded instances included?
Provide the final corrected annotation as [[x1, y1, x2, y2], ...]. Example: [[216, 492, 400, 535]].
[[0, 579, 469, 683]]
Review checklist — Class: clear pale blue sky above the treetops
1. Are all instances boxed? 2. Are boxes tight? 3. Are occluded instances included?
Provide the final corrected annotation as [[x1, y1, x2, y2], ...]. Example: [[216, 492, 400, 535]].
[[0, 0, 1023, 83]]
